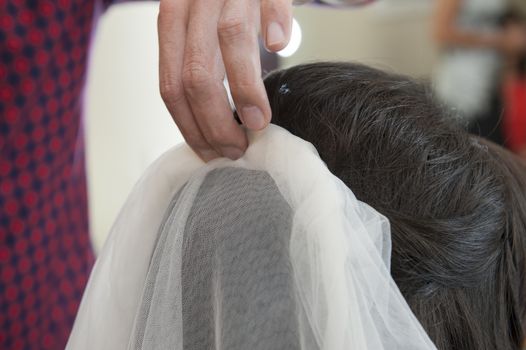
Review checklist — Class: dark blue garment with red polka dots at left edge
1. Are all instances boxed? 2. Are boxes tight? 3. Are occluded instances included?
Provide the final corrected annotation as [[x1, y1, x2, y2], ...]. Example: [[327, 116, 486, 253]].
[[0, 0, 98, 350]]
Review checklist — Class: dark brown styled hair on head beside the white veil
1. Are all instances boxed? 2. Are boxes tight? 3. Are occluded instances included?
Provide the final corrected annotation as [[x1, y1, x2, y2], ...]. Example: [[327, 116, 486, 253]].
[[265, 63, 526, 350]]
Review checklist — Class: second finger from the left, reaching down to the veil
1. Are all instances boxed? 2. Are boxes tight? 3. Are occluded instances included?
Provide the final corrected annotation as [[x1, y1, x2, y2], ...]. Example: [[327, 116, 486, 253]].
[[182, 0, 248, 159]]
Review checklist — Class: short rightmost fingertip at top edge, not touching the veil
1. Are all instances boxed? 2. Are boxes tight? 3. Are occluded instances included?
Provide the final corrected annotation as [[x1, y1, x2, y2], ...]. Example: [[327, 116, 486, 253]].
[[261, 0, 292, 52]]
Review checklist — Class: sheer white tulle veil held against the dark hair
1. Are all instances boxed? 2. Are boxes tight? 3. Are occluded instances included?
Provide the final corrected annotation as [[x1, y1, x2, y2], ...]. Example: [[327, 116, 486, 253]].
[[67, 125, 435, 350]]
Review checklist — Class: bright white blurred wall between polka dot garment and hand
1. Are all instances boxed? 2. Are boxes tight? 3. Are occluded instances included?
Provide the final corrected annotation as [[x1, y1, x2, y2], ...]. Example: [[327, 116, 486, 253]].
[[85, 2, 182, 248]]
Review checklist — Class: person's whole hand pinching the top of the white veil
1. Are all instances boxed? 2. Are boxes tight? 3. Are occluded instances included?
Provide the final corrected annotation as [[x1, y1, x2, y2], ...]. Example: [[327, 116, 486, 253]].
[[158, 0, 292, 161]]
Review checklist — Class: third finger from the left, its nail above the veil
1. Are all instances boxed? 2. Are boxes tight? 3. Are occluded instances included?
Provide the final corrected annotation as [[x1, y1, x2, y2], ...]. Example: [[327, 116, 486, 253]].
[[217, 0, 271, 130]]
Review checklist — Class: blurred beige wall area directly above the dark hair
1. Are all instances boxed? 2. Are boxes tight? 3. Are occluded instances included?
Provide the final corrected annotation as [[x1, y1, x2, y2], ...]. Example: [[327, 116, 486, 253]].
[[282, 0, 437, 77]]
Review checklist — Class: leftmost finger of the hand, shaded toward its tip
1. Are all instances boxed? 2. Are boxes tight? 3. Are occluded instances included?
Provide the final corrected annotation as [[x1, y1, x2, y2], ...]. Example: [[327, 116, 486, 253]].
[[157, 0, 219, 161]]
